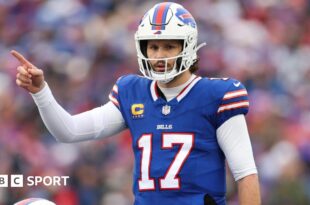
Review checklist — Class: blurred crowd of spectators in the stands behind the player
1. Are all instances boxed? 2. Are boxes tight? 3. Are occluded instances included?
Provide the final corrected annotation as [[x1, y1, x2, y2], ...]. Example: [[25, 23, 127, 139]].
[[0, 0, 310, 205]]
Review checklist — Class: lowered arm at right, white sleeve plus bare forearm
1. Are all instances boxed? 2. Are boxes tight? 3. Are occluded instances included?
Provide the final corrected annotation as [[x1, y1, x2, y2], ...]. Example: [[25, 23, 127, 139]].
[[217, 114, 261, 205]]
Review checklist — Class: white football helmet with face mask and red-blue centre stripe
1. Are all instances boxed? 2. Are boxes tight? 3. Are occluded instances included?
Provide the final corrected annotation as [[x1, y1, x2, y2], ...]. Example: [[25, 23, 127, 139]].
[[135, 2, 205, 83]]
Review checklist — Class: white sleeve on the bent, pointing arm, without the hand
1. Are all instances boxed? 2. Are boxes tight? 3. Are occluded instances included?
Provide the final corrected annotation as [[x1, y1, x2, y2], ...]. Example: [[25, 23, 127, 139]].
[[31, 83, 126, 143]]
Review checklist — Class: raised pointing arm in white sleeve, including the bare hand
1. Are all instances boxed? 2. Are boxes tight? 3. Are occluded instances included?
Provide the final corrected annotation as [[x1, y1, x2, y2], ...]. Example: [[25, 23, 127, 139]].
[[12, 51, 125, 142]]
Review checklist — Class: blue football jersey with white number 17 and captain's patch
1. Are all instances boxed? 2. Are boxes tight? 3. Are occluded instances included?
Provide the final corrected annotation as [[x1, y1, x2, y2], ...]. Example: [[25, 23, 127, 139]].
[[109, 75, 249, 205]]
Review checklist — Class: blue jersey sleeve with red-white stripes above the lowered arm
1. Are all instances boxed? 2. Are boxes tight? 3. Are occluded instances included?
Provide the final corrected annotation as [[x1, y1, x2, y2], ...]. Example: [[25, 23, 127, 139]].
[[216, 79, 250, 127]]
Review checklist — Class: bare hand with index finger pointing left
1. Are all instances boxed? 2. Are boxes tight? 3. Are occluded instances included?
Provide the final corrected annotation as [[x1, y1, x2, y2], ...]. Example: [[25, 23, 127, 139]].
[[11, 50, 44, 93]]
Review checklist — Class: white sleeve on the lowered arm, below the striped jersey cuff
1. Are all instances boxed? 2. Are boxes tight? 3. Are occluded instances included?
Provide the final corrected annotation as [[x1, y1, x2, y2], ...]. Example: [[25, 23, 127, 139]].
[[216, 114, 257, 181]]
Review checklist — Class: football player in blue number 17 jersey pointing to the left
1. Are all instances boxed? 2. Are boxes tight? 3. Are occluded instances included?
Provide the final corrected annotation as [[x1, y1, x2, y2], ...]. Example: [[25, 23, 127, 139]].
[[12, 2, 260, 205]]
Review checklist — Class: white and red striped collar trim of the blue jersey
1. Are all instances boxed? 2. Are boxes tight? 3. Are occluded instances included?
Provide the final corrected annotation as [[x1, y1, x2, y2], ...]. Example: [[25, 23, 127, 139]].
[[150, 76, 201, 102]]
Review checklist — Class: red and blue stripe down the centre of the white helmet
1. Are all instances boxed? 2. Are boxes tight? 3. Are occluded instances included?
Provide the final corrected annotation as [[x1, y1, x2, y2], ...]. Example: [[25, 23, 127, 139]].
[[152, 2, 171, 30]]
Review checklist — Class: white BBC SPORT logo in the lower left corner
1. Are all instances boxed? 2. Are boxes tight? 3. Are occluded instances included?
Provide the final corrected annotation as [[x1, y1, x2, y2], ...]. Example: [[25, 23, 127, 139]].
[[0, 174, 69, 187]]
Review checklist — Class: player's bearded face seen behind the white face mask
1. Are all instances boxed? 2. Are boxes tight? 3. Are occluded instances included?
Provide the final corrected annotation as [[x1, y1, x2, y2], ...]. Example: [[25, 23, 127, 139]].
[[146, 40, 182, 72]]
